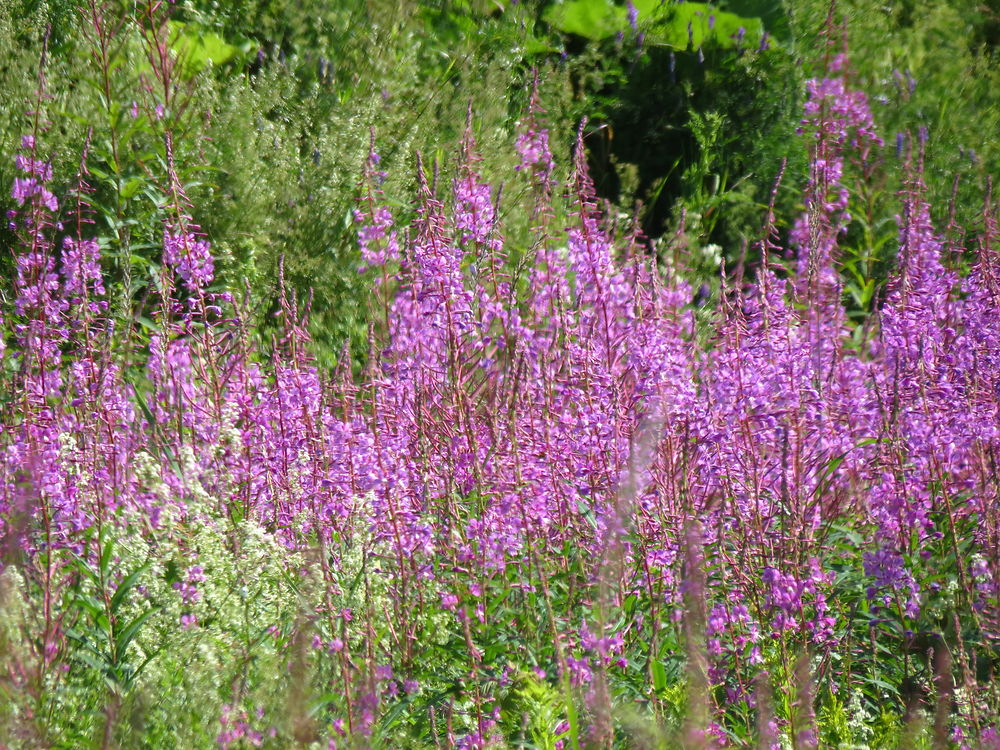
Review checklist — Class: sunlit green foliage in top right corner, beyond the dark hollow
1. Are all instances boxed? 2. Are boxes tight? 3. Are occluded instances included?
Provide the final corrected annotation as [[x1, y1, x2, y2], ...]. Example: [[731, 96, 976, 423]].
[[788, 0, 1000, 248]]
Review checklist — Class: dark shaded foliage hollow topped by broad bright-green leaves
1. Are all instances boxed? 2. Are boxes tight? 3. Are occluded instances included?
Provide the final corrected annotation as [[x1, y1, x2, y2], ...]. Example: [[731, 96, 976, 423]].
[[544, 0, 804, 274]]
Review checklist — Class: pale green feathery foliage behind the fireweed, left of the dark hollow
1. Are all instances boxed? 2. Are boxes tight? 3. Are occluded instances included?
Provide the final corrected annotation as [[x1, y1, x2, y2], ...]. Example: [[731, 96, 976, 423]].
[[0, 0, 569, 365]]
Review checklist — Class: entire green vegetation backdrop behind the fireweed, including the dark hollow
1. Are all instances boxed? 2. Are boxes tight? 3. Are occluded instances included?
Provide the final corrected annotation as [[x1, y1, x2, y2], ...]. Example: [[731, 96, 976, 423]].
[[0, 0, 1000, 365]]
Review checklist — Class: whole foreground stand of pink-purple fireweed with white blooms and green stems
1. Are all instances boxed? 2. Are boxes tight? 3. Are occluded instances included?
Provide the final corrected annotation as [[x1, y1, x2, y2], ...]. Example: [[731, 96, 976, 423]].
[[0, 27, 1000, 750]]
